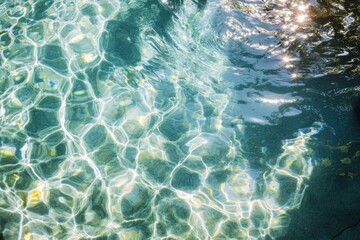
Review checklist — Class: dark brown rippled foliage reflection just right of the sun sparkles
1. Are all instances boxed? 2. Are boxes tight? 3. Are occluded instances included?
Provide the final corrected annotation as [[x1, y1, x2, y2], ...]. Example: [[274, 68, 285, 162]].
[[296, 0, 360, 73]]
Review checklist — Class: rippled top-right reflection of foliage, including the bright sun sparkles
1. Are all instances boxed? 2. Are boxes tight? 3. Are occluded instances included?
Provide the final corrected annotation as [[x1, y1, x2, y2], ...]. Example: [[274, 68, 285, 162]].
[[225, 0, 360, 77]]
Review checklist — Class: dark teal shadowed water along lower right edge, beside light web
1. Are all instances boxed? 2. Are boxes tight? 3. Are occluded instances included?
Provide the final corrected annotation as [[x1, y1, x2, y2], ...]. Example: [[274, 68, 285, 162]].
[[279, 98, 360, 240]]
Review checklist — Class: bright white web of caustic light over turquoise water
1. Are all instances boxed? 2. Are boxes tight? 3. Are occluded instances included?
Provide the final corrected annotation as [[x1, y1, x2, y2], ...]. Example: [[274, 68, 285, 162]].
[[0, 0, 320, 239]]
